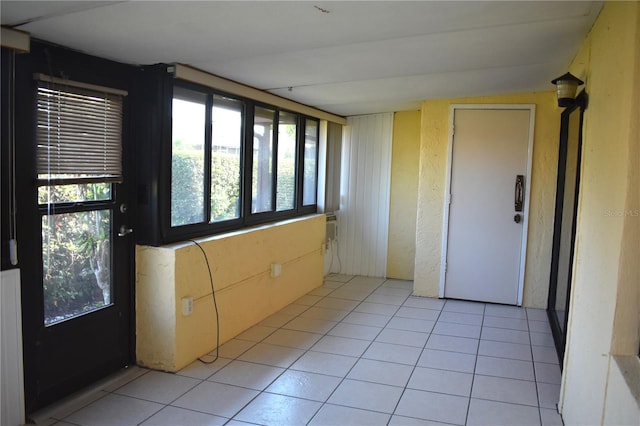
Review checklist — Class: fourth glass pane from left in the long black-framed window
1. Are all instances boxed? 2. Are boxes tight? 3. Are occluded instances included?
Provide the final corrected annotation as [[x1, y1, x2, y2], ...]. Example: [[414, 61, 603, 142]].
[[276, 112, 298, 211]]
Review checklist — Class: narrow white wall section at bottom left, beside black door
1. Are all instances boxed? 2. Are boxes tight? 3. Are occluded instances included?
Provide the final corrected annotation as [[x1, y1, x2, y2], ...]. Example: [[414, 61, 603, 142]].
[[0, 269, 25, 426]]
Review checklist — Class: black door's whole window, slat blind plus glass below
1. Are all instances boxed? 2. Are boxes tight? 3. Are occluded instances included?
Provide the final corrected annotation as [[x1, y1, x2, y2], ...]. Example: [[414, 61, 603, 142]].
[[36, 78, 125, 326]]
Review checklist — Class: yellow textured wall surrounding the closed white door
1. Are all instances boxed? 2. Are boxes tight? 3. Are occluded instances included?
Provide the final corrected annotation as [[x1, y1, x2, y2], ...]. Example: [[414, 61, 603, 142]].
[[414, 88, 560, 308]]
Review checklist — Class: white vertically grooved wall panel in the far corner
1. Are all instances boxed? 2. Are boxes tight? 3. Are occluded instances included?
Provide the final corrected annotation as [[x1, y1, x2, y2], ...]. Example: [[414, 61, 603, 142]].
[[336, 113, 393, 277]]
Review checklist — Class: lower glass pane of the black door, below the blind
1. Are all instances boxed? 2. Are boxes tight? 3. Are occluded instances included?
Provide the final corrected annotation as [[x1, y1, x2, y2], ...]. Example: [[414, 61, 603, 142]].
[[42, 210, 112, 325]]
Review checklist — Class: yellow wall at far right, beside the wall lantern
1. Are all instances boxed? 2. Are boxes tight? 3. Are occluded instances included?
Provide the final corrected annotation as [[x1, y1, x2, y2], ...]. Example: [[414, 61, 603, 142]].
[[560, 2, 640, 424]]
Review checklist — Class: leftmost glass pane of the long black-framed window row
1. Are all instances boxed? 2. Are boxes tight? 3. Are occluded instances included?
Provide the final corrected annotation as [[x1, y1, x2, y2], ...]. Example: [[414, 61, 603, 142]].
[[171, 87, 206, 226]]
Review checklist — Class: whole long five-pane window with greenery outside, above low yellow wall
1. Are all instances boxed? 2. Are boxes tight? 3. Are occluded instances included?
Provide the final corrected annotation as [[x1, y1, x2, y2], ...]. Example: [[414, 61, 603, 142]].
[[170, 83, 320, 240]]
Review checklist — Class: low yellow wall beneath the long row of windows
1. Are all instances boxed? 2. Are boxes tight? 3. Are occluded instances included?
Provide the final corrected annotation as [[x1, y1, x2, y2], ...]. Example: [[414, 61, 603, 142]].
[[136, 215, 325, 371]]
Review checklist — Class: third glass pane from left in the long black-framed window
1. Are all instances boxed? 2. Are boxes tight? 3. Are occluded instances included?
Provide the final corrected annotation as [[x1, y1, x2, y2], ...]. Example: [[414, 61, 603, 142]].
[[251, 107, 275, 213]]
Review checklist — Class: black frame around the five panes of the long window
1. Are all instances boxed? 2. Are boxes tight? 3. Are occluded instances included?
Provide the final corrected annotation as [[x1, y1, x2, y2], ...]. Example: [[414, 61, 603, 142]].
[[160, 79, 320, 244]]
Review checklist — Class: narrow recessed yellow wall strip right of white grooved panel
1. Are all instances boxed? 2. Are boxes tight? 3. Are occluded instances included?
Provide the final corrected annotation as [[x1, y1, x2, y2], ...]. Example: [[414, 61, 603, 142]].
[[387, 111, 420, 280]]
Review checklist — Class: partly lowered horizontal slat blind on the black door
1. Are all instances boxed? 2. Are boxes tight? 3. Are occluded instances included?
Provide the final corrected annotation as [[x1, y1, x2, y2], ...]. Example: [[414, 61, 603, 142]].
[[36, 78, 126, 185]]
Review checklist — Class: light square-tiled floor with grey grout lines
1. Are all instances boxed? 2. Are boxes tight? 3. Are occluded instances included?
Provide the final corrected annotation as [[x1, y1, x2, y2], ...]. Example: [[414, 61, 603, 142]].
[[36, 275, 562, 426]]
